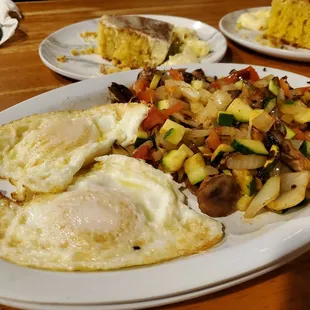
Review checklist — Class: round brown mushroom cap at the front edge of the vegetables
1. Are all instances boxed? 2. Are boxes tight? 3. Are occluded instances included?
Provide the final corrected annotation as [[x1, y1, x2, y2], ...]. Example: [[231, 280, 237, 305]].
[[197, 174, 240, 217]]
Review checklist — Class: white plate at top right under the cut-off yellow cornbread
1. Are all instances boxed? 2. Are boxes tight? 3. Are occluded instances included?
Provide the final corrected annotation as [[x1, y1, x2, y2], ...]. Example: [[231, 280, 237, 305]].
[[219, 7, 310, 62]]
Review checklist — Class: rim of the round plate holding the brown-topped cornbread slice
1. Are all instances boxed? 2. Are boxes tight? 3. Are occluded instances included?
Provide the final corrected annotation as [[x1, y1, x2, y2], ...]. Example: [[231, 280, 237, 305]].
[[38, 14, 227, 81]]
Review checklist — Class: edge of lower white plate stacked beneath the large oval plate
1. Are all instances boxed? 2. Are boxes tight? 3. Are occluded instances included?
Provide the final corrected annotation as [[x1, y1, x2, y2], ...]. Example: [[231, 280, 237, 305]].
[[0, 245, 310, 310]]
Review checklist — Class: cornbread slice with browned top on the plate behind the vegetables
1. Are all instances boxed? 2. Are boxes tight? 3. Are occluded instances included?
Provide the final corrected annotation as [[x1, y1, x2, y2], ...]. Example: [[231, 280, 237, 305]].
[[97, 15, 173, 68]]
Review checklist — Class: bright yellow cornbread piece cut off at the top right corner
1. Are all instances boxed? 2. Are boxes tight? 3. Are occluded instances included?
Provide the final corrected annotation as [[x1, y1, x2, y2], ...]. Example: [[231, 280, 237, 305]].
[[266, 0, 310, 49]]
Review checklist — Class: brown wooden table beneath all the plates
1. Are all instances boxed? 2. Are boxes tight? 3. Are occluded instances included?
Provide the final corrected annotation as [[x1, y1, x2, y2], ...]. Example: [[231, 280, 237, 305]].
[[0, 0, 310, 310]]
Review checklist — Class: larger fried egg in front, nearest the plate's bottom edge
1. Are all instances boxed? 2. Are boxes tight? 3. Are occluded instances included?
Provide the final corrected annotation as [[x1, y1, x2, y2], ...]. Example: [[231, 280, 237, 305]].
[[0, 155, 223, 271]]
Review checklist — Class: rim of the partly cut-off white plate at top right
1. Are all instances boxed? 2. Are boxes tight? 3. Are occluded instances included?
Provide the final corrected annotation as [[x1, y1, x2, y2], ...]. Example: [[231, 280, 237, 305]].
[[219, 6, 310, 62]]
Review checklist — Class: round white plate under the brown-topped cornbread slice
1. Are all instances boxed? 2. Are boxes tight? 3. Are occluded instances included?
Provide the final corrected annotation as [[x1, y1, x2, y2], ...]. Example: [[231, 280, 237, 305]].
[[39, 15, 227, 80]]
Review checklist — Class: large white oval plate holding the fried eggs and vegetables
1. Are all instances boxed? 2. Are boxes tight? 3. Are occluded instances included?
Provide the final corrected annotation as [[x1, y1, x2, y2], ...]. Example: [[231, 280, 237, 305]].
[[0, 64, 310, 306]]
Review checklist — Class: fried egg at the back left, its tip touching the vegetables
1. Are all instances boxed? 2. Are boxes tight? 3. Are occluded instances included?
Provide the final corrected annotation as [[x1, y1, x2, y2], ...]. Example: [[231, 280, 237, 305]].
[[0, 103, 149, 201]]
